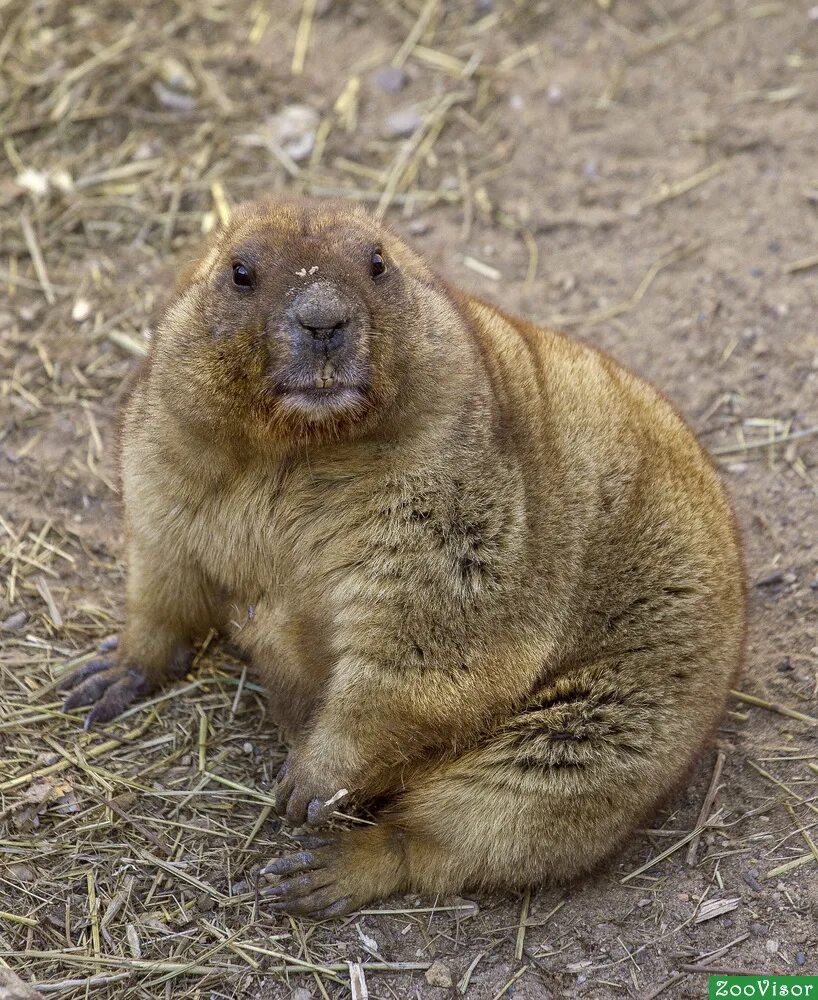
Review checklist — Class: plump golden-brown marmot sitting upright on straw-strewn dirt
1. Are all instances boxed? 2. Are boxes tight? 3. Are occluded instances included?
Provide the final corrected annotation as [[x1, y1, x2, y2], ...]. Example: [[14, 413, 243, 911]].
[[60, 200, 744, 916]]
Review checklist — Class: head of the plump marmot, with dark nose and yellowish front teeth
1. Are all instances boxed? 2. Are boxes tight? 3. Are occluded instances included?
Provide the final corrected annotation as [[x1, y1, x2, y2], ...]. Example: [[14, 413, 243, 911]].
[[152, 200, 457, 441]]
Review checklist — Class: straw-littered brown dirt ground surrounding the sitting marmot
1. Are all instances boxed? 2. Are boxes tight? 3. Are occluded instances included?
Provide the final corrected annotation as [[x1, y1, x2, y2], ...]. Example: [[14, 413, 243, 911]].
[[0, 0, 818, 1000]]
